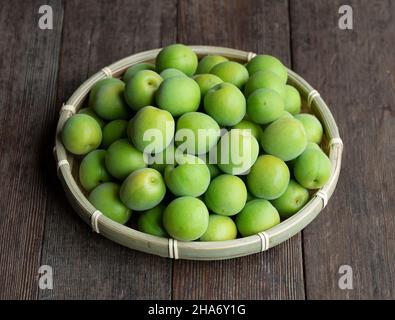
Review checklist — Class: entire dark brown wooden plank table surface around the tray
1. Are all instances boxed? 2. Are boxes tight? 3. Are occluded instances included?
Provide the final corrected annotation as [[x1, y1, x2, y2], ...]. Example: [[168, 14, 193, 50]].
[[0, 0, 395, 299]]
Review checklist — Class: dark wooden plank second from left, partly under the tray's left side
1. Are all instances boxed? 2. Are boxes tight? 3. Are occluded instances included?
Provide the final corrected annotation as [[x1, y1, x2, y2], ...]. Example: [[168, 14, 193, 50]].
[[40, 0, 176, 299]]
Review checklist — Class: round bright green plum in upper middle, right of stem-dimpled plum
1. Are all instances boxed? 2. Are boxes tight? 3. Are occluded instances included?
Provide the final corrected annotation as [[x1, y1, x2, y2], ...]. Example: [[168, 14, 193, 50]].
[[156, 77, 200, 117]]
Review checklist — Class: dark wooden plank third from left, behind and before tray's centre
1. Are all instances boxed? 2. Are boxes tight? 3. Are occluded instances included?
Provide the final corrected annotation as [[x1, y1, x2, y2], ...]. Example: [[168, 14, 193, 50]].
[[173, 0, 304, 299]]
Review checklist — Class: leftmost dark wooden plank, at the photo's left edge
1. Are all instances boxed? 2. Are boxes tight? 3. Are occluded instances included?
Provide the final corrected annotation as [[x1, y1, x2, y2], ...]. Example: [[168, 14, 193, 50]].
[[0, 0, 63, 299]]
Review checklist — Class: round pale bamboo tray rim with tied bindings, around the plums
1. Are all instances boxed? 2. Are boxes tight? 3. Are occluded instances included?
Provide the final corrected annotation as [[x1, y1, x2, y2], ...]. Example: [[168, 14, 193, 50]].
[[54, 46, 343, 260]]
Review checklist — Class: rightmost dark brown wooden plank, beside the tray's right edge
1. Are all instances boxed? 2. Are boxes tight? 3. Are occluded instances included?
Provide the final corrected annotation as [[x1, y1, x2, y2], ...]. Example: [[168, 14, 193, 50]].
[[290, 0, 395, 299]]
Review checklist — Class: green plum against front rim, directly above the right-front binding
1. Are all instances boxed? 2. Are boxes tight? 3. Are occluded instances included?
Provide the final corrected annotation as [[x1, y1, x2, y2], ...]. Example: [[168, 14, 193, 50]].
[[236, 199, 280, 237]]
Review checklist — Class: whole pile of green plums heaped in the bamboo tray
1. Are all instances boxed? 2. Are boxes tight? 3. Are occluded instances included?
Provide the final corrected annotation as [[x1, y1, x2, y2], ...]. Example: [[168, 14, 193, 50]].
[[62, 44, 331, 241]]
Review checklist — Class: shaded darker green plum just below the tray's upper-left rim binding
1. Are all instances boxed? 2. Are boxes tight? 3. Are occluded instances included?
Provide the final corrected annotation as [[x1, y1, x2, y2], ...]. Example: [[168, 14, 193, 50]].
[[89, 78, 130, 120]]
